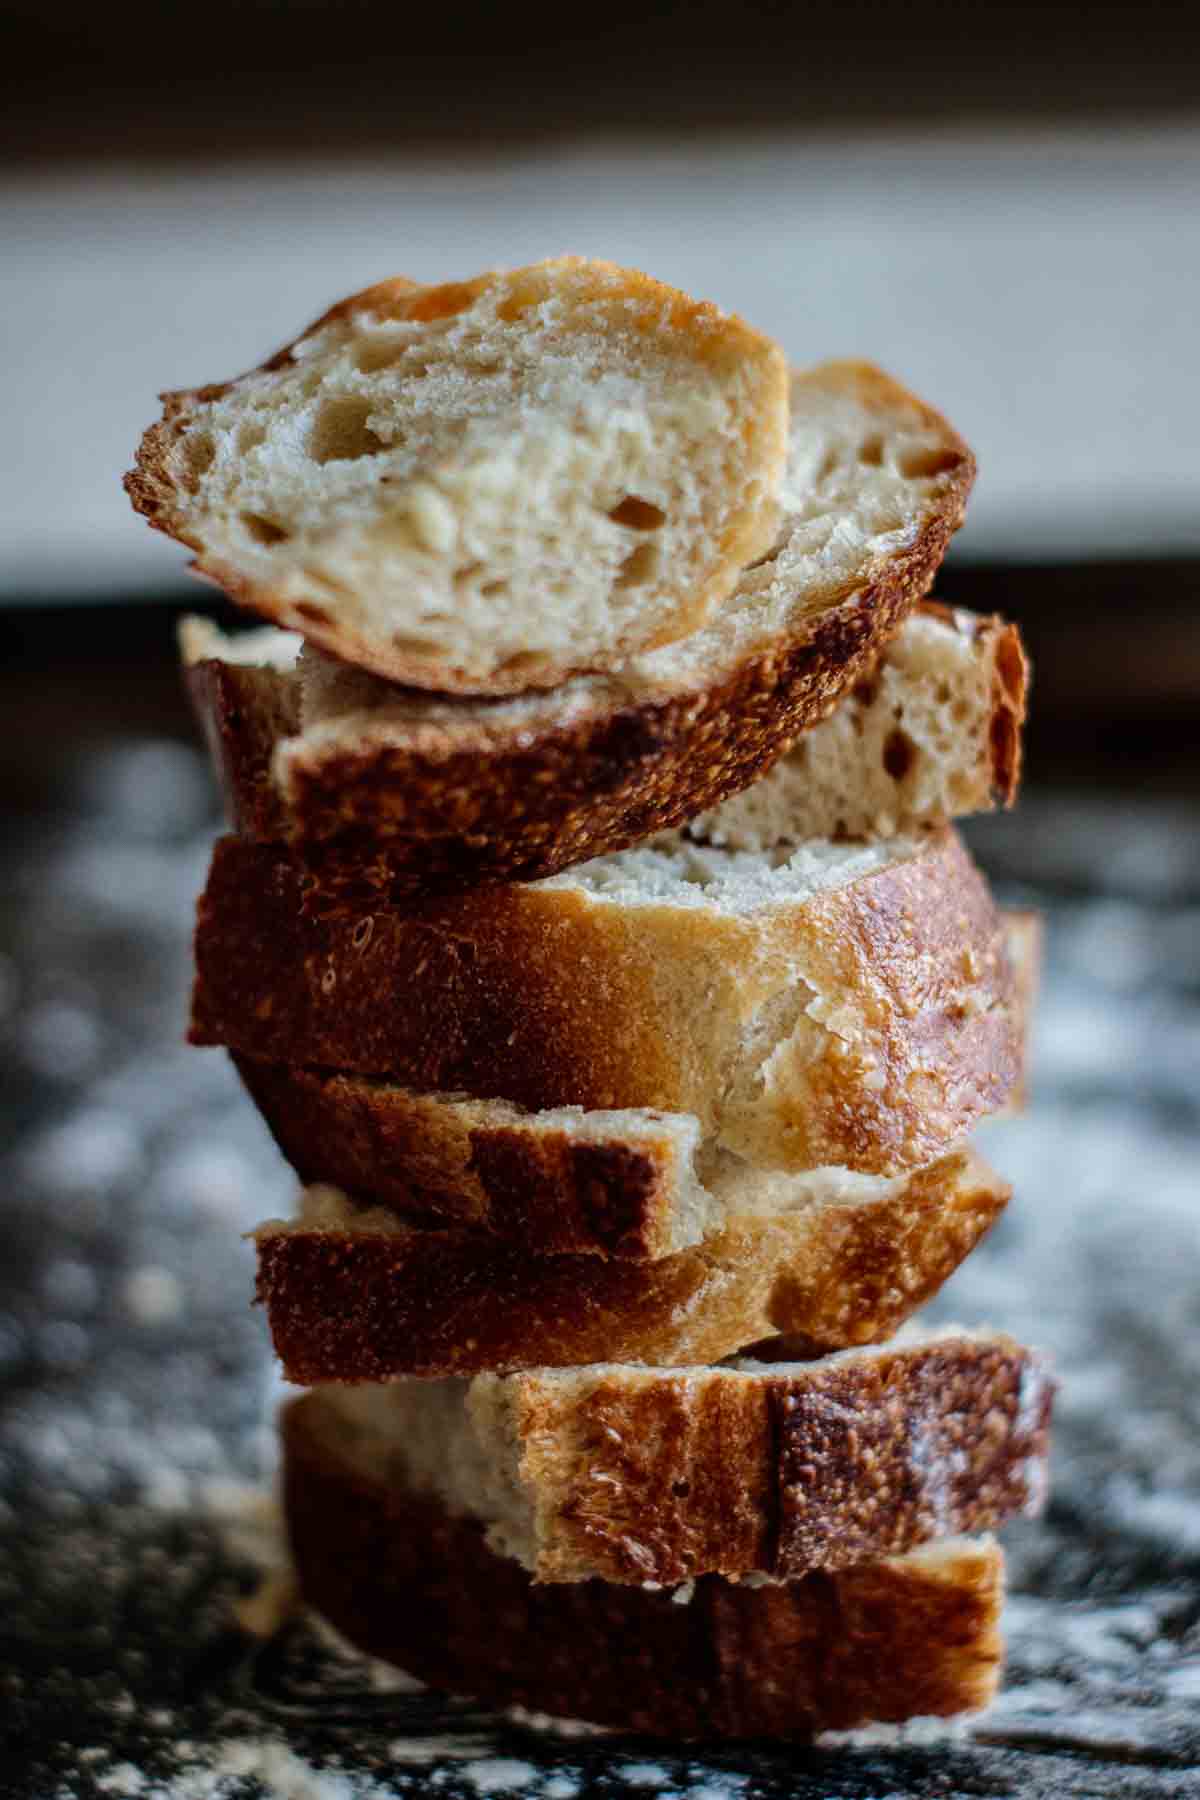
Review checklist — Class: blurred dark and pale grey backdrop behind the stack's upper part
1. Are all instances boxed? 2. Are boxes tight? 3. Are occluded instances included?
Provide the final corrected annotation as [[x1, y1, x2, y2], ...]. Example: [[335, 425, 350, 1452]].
[[0, 0, 1200, 805]]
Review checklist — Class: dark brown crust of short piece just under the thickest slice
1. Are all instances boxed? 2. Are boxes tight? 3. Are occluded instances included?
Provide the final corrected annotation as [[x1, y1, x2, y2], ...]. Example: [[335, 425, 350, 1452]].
[[234, 1055, 689, 1262]]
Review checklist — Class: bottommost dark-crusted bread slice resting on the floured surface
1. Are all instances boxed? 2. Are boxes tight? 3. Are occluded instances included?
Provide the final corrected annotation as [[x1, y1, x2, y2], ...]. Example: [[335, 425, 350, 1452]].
[[282, 1395, 1004, 1739]]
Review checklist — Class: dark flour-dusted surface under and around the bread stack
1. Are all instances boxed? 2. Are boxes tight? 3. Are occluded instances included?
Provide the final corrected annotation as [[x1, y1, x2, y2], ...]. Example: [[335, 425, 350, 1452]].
[[0, 743, 1200, 1800]]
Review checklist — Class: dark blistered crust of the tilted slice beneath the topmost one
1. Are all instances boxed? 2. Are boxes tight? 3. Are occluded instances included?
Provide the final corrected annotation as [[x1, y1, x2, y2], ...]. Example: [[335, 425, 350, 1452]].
[[187, 565, 978, 905]]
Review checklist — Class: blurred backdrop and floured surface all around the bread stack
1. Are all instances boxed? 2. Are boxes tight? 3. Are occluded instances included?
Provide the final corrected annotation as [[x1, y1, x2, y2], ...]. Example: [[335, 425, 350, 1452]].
[[0, 0, 1200, 1800]]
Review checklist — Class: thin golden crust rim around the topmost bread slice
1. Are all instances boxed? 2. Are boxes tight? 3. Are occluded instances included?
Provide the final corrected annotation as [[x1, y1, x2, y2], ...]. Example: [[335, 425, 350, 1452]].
[[124, 256, 788, 695]]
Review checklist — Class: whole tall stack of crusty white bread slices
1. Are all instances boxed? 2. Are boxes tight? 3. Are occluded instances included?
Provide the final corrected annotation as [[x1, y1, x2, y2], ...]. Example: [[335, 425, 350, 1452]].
[[128, 259, 1052, 1737]]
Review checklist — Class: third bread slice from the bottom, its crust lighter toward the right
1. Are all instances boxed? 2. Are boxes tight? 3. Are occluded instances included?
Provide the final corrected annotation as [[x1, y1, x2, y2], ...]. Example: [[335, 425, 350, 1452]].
[[255, 1150, 1009, 1386]]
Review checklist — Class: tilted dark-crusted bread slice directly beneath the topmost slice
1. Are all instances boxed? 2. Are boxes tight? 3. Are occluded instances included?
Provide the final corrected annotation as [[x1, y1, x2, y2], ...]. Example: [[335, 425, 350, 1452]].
[[182, 364, 978, 891]]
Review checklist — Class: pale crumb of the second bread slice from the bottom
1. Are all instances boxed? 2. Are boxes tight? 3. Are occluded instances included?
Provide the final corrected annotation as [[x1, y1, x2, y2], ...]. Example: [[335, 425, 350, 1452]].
[[322, 1323, 1011, 1571]]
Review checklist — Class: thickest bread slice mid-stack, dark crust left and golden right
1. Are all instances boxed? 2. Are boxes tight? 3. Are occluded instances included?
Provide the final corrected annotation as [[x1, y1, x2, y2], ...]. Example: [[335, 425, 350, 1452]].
[[191, 828, 1020, 1174]]
